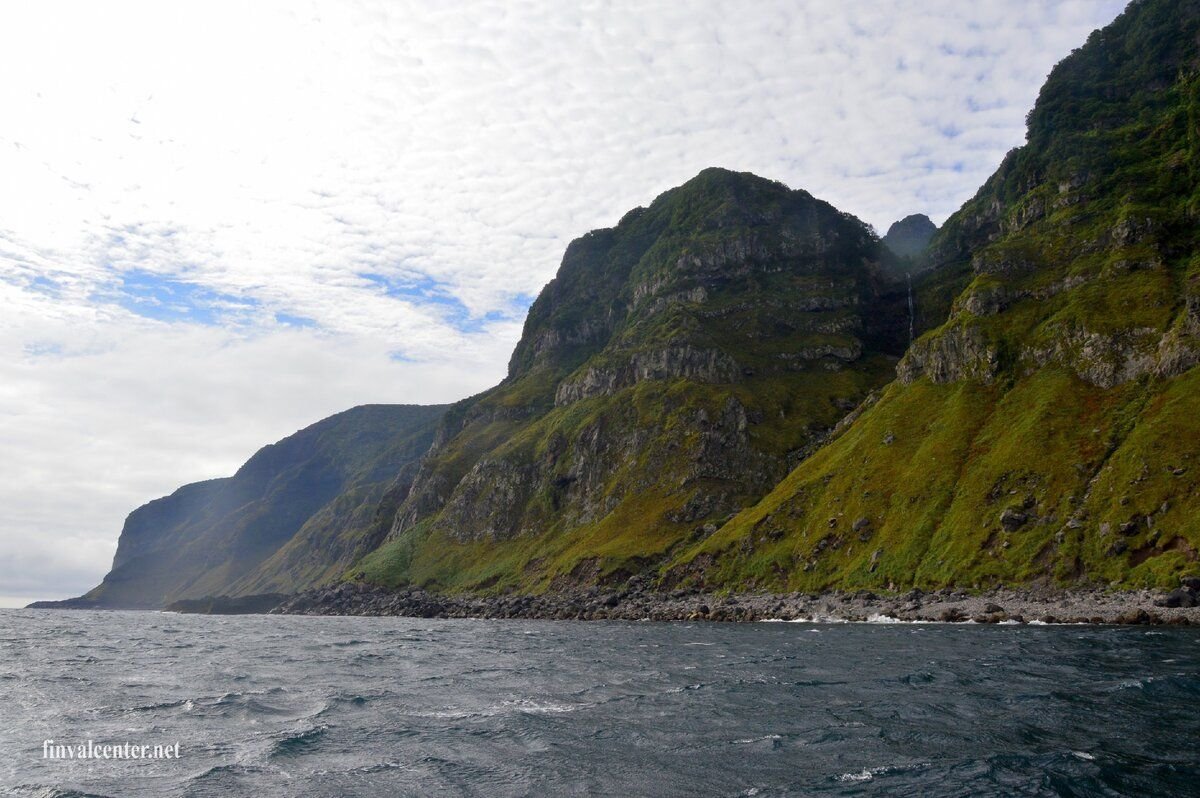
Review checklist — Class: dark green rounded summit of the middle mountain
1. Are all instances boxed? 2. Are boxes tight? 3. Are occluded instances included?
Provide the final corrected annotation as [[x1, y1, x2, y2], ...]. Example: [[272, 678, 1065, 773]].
[[509, 168, 877, 379]]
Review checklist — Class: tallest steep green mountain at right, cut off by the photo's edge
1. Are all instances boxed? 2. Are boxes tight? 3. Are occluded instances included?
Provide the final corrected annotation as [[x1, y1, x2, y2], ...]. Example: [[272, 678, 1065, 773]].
[[667, 0, 1200, 589]]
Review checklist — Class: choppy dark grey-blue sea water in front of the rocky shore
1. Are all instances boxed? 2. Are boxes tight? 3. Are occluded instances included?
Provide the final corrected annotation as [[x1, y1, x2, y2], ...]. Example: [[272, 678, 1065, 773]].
[[0, 611, 1200, 798]]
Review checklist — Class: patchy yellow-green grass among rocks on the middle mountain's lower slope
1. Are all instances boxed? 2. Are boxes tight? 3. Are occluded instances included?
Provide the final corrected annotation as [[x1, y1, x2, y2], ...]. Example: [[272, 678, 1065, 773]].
[[356, 356, 893, 590]]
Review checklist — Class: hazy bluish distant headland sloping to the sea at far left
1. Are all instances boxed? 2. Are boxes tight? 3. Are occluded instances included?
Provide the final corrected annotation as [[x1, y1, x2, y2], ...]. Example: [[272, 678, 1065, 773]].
[[51, 406, 444, 608]]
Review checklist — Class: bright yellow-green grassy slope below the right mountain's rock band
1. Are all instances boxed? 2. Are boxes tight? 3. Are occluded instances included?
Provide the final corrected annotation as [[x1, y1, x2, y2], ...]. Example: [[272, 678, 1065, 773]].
[[671, 368, 1200, 590]]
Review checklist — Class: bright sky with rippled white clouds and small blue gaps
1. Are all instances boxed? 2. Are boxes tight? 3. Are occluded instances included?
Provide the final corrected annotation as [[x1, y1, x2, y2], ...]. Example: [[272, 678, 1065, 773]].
[[0, 0, 1123, 606]]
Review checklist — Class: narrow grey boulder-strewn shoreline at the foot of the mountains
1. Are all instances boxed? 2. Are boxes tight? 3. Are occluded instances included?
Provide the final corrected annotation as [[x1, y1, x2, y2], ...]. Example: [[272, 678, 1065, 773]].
[[271, 577, 1200, 625]]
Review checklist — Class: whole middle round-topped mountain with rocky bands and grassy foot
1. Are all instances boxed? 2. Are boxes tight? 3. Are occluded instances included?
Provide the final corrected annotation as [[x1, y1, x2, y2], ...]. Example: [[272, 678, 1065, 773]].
[[362, 169, 906, 589]]
